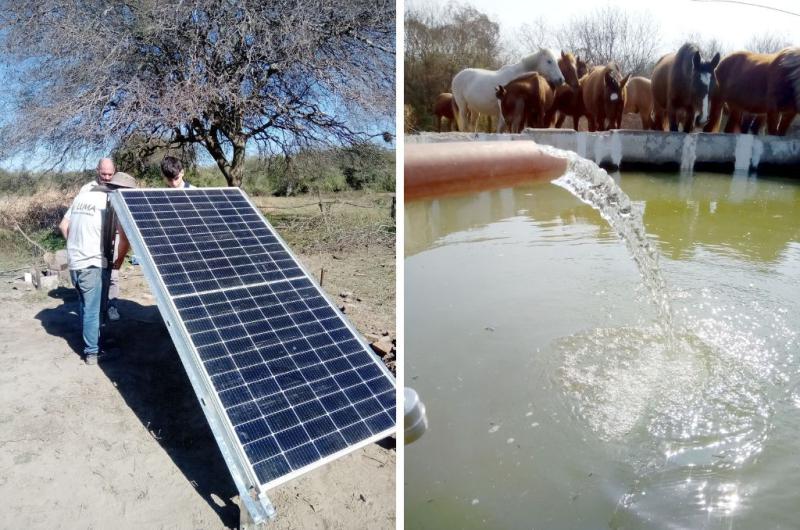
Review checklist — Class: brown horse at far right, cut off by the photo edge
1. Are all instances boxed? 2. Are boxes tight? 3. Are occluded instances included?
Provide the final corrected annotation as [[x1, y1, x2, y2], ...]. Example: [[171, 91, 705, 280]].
[[704, 48, 800, 136]]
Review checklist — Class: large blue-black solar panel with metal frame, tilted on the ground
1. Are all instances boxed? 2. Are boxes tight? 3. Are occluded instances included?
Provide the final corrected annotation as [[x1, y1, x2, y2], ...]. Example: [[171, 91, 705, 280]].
[[112, 188, 395, 522]]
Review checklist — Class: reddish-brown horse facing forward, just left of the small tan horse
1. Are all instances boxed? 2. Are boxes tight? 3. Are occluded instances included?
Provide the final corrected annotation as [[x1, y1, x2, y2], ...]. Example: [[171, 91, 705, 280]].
[[581, 63, 631, 132]]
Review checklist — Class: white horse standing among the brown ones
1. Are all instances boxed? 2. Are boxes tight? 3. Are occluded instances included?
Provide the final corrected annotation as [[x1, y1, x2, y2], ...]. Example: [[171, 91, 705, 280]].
[[450, 50, 564, 132]]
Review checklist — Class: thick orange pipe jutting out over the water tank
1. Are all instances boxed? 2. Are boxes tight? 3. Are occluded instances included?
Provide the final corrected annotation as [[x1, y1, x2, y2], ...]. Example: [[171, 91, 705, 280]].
[[404, 141, 567, 200]]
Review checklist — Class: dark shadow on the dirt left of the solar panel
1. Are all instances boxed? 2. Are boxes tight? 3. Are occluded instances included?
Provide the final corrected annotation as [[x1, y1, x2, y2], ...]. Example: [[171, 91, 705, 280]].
[[36, 287, 239, 528]]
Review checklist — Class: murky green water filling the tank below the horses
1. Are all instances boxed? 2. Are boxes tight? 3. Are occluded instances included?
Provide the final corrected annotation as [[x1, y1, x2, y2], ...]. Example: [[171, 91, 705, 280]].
[[405, 173, 800, 529]]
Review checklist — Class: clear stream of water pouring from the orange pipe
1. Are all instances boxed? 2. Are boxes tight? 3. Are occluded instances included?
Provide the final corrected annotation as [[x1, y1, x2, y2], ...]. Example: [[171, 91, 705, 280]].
[[545, 149, 675, 343]]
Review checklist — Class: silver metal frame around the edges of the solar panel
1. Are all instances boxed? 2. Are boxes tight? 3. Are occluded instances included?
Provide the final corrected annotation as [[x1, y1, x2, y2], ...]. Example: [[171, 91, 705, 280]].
[[111, 187, 397, 523]]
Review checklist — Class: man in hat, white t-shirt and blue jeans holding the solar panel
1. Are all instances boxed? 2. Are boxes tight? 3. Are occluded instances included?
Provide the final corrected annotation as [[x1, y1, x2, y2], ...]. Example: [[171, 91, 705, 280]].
[[59, 171, 136, 364]]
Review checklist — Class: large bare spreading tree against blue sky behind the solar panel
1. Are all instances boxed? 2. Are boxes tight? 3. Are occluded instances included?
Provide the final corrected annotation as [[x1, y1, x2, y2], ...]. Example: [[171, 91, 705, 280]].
[[0, 0, 396, 186]]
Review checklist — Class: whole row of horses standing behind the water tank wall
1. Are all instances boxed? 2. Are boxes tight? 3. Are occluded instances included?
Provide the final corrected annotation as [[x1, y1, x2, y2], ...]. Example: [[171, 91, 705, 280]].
[[434, 43, 800, 136]]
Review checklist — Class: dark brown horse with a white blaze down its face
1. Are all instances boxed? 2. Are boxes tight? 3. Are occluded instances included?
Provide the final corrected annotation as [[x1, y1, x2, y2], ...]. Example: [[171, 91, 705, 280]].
[[651, 42, 719, 132]]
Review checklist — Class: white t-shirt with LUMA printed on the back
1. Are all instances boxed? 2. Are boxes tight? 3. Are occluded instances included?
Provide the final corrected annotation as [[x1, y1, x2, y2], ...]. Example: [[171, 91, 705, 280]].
[[64, 184, 108, 270]]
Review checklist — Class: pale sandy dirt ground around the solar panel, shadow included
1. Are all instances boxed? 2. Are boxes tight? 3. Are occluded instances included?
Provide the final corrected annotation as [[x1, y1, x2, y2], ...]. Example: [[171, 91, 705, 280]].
[[0, 242, 395, 530]]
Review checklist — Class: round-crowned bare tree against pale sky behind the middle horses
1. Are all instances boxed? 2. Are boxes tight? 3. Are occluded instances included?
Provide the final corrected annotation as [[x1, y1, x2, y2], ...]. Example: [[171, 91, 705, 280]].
[[556, 6, 660, 74]]
